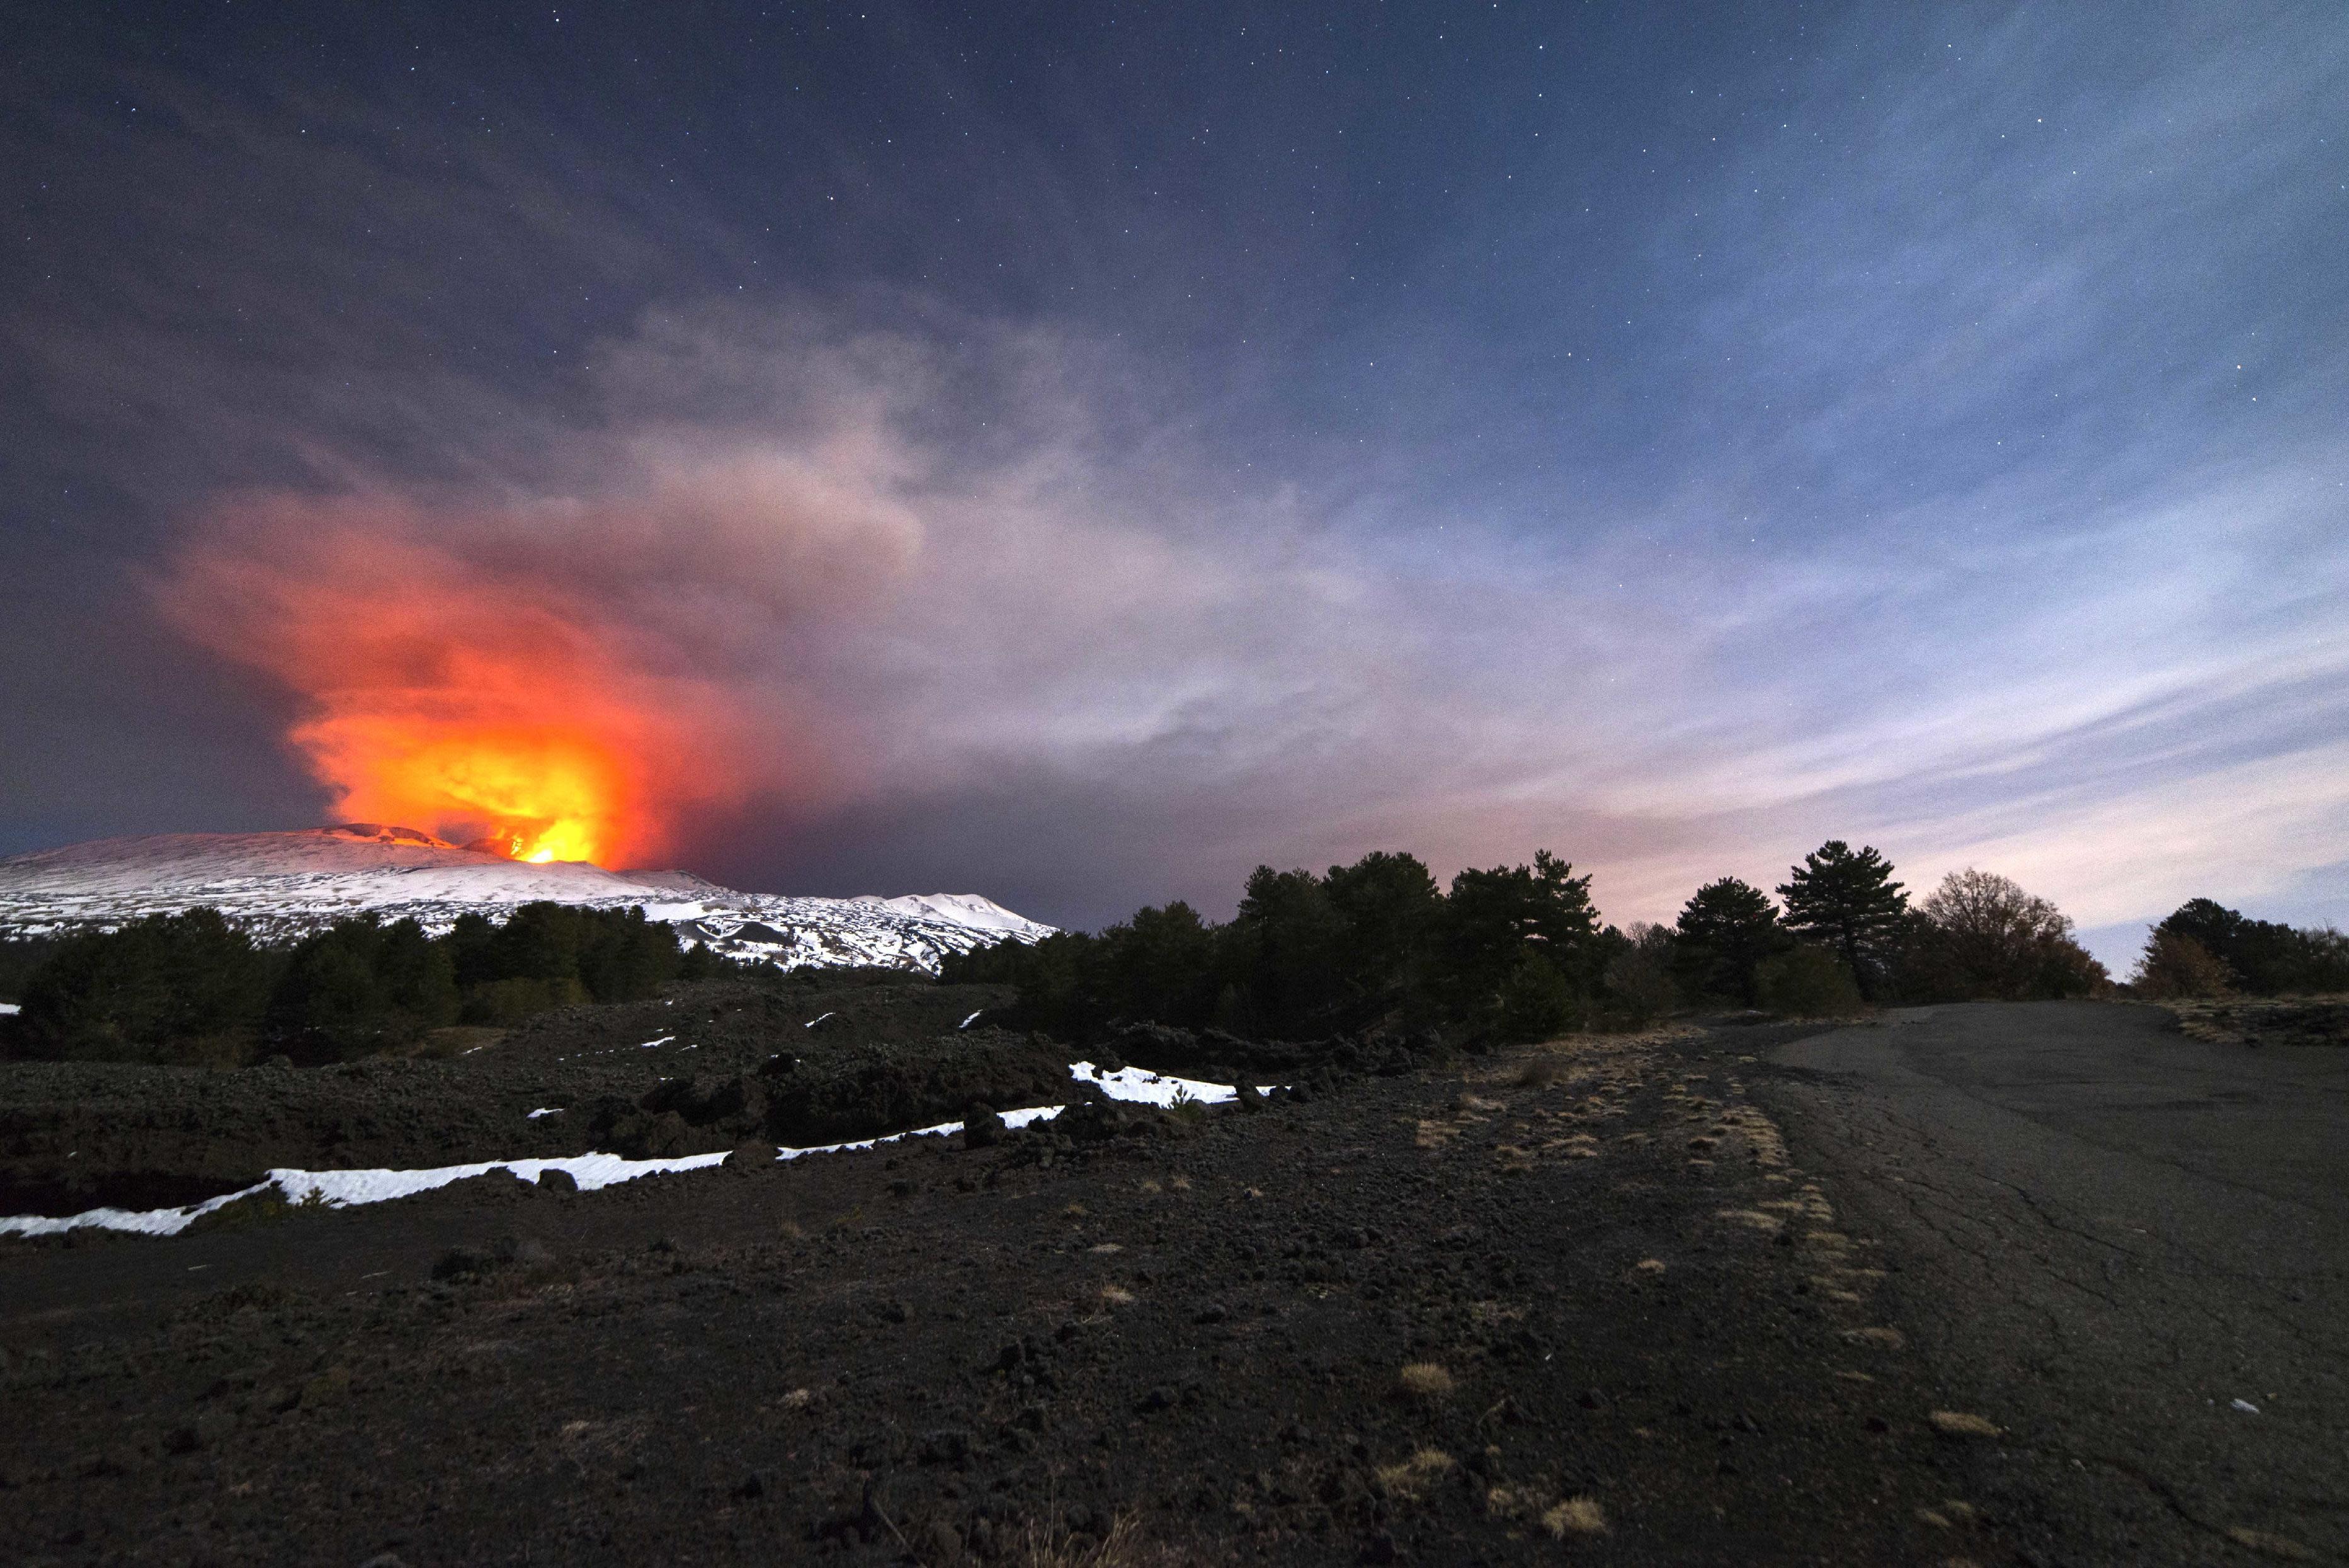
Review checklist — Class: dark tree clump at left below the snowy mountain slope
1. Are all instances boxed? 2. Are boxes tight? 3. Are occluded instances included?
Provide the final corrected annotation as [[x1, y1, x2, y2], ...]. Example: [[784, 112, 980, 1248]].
[[9, 904, 733, 1065]]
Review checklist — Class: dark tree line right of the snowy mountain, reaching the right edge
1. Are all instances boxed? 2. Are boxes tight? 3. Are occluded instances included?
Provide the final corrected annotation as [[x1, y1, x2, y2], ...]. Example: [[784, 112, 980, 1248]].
[[947, 840, 2349, 1045]]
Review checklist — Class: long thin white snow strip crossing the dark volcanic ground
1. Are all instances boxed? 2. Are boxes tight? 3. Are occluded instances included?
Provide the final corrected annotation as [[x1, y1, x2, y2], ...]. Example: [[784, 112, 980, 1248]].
[[0, 1061, 1278, 1237]]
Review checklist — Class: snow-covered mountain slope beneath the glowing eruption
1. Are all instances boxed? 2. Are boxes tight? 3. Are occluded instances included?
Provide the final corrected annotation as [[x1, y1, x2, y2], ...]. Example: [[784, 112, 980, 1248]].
[[0, 822, 1052, 969]]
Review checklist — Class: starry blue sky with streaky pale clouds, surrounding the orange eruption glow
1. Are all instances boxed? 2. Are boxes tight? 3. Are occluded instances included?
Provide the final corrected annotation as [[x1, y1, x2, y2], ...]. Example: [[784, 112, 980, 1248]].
[[0, 0, 2349, 967]]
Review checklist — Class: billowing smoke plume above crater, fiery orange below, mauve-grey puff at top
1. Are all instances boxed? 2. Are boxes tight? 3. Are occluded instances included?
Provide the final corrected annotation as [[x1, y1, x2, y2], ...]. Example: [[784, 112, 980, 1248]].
[[155, 434, 918, 866]]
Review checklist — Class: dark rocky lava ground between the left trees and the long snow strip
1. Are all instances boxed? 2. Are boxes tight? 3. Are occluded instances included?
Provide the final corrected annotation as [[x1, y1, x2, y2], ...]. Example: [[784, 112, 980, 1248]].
[[0, 972, 1028, 1213]]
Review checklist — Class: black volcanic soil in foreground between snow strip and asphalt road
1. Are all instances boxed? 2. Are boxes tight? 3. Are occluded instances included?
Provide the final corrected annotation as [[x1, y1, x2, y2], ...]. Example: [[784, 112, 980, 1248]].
[[0, 993, 2049, 1568]]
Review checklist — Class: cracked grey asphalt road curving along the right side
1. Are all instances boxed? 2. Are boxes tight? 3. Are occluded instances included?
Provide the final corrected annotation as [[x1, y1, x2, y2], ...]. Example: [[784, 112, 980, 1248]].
[[1757, 1003, 2349, 1564]]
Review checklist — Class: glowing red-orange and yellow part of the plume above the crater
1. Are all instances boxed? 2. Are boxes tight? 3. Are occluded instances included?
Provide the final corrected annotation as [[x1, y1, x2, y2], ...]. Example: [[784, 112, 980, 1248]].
[[162, 514, 780, 866]]
